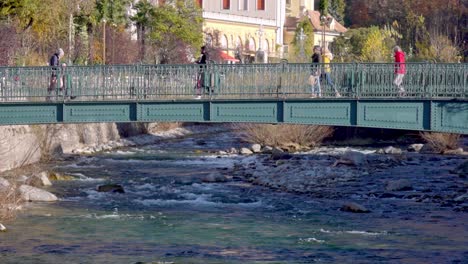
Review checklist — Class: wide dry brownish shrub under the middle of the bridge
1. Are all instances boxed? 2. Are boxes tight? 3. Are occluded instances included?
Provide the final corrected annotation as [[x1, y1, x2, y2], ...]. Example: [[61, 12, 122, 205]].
[[235, 123, 333, 150]]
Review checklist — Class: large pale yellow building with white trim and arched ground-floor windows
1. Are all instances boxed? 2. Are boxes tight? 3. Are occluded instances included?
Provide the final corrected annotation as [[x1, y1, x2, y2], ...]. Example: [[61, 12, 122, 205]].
[[202, 0, 286, 62]]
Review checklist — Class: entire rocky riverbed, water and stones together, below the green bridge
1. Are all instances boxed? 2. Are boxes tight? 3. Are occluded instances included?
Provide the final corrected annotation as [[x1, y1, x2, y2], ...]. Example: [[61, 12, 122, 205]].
[[0, 128, 468, 264]]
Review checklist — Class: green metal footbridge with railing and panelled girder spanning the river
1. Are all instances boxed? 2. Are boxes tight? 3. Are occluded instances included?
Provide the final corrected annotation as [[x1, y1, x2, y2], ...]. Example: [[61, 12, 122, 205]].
[[0, 63, 468, 134]]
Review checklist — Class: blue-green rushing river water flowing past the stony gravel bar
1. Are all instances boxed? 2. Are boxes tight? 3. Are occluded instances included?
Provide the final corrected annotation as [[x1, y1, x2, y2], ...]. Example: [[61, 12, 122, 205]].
[[0, 134, 468, 264]]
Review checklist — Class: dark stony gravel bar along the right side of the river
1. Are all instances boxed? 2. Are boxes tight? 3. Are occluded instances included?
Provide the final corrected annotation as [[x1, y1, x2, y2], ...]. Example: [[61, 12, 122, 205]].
[[220, 144, 468, 213]]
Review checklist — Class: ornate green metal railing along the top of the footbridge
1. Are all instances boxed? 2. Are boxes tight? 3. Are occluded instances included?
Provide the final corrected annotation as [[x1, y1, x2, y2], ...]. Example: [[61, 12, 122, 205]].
[[0, 63, 468, 102]]
